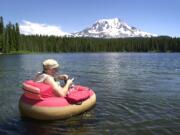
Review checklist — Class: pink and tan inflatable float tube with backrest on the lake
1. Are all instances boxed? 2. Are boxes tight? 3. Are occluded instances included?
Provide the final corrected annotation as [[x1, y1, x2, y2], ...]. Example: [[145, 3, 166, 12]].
[[19, 80, 96, 120]]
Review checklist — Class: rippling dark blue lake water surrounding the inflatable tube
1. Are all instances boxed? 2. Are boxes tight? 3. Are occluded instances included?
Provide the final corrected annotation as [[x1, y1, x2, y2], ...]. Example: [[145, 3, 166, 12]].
[[0, 53, 180, 135]]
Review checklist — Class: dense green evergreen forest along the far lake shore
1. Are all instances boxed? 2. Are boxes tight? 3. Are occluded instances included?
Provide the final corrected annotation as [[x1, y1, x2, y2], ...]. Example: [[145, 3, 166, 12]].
[[0, 17, 180, 53]]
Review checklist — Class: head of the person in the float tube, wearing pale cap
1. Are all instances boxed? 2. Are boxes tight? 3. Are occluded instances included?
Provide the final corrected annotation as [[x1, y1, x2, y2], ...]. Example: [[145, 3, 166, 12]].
[[42, 59, 59, 75]]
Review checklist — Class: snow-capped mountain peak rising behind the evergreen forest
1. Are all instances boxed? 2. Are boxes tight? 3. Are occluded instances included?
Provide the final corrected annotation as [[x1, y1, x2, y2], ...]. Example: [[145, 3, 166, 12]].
[[72, 18, 157, 38]]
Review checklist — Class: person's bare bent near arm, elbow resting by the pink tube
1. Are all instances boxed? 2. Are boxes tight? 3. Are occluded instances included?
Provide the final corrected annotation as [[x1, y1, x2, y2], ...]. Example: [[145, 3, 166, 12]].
[[45, 76, 73, 97]]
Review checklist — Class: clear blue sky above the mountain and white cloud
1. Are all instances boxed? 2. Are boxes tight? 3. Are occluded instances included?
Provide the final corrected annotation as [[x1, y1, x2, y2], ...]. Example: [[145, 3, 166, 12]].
[[0, 0, 180, 37]]
